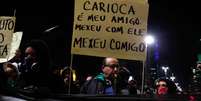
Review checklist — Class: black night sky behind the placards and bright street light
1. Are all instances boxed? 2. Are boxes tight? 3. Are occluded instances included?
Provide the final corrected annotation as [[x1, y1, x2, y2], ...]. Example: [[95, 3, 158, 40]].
[[0, 0, 201, 90]]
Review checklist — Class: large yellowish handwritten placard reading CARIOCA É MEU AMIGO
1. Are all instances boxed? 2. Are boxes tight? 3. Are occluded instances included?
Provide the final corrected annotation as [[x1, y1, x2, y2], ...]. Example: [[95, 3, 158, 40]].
[[71, 0, 148, 60]]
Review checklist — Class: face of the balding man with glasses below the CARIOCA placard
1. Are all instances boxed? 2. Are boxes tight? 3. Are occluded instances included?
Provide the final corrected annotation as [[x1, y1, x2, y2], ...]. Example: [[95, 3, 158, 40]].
[[102, 58, 119, 78]]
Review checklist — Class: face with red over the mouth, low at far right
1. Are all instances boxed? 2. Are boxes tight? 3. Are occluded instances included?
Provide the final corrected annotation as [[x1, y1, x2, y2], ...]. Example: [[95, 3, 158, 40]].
[[157, 81, 168, 95]]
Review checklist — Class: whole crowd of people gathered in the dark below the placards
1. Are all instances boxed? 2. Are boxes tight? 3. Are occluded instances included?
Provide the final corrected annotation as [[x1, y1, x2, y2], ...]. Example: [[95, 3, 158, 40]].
[[0, 40, 196, 96]]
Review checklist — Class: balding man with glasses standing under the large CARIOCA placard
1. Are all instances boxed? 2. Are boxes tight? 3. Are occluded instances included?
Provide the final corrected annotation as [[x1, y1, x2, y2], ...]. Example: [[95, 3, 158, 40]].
[[81, 57, 133, 95]]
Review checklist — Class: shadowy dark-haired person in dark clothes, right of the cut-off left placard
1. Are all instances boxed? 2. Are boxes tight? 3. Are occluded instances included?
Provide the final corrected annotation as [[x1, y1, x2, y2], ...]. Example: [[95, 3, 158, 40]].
[[19, 40, 51, 94]]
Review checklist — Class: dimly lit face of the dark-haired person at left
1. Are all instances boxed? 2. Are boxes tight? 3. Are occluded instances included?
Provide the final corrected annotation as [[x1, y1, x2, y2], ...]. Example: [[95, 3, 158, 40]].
[[25, 47, 36, 62]]
